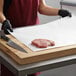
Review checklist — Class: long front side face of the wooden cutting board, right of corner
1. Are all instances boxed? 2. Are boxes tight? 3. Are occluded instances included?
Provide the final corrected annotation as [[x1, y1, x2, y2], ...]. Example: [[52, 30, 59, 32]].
[[14, 48, 76, 65]]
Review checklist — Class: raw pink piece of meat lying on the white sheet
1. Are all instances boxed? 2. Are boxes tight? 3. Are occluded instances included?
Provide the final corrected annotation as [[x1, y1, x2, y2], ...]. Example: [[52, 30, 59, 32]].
[[31, 39, 55, 48]]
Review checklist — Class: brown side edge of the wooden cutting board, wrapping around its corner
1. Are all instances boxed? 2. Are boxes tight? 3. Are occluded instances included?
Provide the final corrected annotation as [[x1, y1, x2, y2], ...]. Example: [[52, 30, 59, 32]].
[[0, 38, 76, 64]]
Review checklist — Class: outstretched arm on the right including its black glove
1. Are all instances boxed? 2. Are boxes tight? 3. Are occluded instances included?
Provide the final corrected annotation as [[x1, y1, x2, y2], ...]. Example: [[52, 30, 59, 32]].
[[38, 0, 72, 17]]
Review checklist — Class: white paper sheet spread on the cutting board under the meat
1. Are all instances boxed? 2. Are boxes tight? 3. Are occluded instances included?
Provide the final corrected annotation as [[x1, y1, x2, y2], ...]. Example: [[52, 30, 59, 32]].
[[12, 16, 76, 51]]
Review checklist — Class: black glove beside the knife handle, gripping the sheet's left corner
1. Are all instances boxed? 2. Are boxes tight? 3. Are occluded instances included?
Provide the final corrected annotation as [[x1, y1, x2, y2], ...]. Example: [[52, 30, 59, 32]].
[[2, 20, 13, 34]]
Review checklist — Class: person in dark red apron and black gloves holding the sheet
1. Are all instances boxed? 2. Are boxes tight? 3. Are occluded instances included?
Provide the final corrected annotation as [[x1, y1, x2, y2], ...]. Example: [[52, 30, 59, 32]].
[[0, 0, 71, 76]]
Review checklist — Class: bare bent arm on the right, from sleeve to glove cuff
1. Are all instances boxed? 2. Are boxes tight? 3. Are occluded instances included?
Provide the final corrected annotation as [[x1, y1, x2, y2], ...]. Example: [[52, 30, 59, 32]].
[[38, 0, 59, 16]]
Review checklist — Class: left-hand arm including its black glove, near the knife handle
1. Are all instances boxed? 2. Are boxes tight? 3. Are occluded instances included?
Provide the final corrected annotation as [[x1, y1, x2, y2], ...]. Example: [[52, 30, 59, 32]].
[[0, 0, 13, 34]]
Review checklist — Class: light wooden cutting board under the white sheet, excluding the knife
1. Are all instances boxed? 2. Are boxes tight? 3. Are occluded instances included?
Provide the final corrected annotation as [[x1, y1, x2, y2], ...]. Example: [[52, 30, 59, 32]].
[[0, 35, 76, 64]]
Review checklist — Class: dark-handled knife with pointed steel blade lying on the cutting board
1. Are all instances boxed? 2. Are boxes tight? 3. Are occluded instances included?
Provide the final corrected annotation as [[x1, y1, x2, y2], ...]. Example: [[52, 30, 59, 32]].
[[0, 30, 27, 53]]
